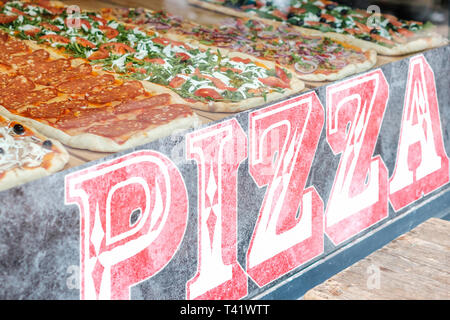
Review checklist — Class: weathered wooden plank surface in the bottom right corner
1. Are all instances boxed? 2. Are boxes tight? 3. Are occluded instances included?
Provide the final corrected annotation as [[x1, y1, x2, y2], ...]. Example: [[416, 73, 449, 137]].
[[304, 218, 450, 300]]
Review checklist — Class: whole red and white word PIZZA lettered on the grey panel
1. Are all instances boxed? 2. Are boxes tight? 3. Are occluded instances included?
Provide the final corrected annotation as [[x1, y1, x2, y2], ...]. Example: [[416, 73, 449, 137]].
[[65, 55, 450, 299]]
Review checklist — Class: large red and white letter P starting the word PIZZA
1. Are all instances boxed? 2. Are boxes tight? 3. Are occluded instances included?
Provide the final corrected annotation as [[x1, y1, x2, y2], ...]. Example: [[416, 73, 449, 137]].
[[66, 151, 188, 299]]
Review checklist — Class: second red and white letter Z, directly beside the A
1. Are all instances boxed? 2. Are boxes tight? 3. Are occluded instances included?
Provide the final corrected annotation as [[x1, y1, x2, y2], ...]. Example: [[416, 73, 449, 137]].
[[325, 69, 389, 244]]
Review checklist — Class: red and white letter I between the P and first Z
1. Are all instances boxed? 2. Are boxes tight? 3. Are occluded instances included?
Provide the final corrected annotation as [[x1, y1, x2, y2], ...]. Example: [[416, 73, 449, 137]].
[[186, 119, 247, 300]]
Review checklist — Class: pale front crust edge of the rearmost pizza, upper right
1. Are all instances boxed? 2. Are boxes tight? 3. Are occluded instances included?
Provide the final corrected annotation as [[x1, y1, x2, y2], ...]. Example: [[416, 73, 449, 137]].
[[188, 0, 448, 56]]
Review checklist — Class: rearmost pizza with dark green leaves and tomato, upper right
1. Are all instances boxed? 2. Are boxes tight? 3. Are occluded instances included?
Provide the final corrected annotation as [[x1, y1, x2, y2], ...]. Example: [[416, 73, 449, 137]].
[[188, 0, 448, 56]]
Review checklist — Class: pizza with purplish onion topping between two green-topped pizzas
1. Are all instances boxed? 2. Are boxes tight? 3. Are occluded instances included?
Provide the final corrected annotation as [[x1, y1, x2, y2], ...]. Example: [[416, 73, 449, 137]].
[[102, 8, 377, 81]]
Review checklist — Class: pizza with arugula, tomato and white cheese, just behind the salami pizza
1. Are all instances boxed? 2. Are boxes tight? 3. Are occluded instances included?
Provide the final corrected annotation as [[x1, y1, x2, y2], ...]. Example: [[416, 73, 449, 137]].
[[0, 1, 304, 112]]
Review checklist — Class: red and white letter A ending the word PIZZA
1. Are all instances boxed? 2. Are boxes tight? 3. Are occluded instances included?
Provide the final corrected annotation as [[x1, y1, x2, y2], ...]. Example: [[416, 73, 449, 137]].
[[390, 55, 449, 211]]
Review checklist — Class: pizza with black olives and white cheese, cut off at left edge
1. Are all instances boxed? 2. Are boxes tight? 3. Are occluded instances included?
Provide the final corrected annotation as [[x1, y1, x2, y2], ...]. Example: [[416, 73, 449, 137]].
[[0, 116, 69, 191]]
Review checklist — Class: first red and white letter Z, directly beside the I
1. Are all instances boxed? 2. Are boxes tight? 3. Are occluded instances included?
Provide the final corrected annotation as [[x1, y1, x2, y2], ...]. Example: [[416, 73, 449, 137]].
[[247, 92, 324, 286]]
